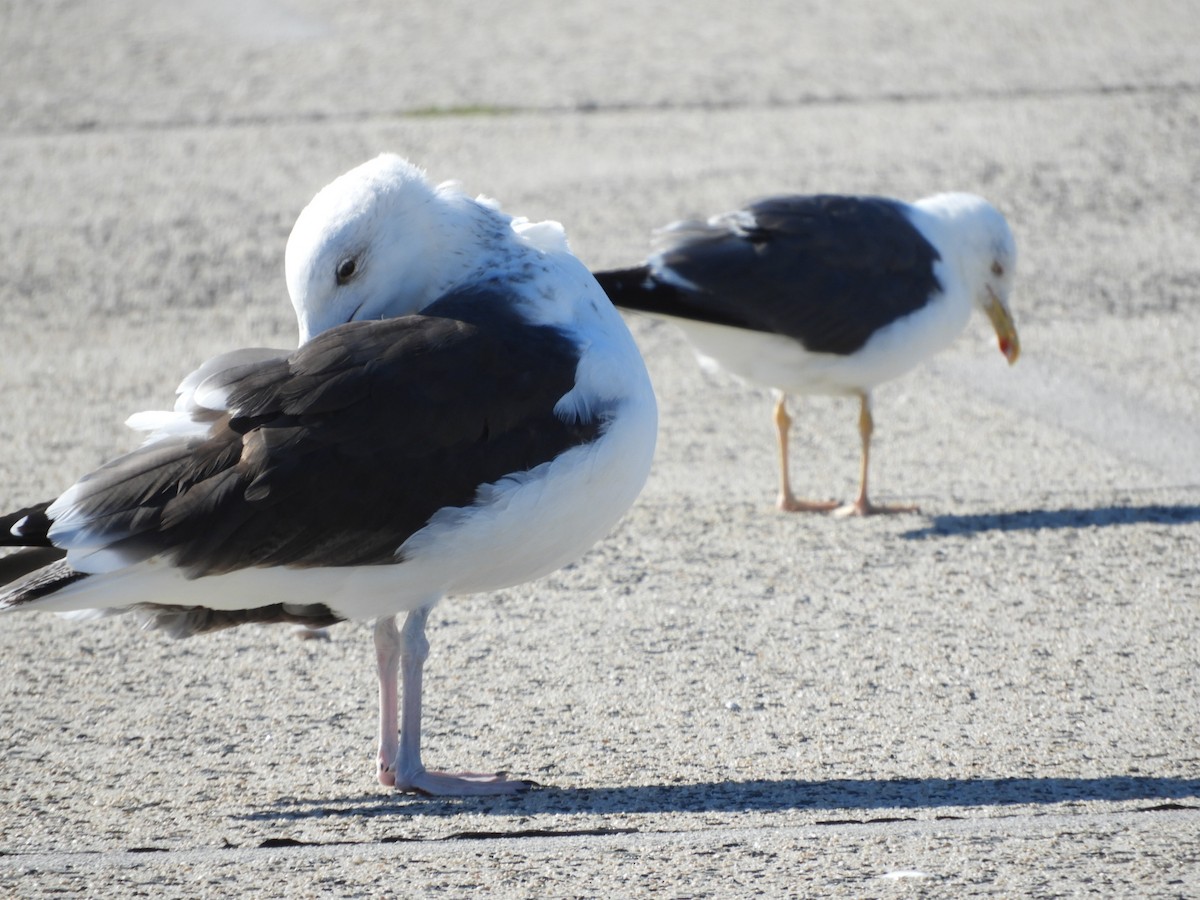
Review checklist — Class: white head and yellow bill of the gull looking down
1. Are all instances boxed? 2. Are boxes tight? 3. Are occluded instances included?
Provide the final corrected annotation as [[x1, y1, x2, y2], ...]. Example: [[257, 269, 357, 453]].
[[917, 193, 1021, 364]]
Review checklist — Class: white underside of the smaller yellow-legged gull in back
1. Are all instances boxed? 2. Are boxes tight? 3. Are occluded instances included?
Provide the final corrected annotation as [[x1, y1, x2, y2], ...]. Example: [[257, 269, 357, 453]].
[[668, 283, 971, 395]]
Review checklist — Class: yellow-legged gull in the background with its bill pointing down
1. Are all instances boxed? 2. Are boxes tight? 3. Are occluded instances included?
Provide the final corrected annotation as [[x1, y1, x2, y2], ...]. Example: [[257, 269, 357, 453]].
[[595, 193, 1020, 516]]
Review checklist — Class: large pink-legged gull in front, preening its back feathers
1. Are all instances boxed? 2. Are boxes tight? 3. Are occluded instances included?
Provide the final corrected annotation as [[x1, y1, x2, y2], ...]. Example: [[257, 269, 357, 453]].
[[0, 155, 656, 794]]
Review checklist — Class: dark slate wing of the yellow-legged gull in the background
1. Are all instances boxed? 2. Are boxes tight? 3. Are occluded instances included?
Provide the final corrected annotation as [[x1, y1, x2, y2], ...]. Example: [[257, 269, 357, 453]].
[[633, 196, 940, 355]]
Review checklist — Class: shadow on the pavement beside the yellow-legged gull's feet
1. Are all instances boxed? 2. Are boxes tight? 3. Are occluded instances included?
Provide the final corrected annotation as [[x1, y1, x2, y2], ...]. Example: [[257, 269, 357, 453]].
[[900, 504, 1200, 540]]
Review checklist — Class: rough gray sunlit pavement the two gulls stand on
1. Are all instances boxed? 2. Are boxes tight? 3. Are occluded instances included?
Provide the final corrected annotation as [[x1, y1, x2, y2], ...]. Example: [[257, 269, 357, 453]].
[[0, 0, 1200, 898]]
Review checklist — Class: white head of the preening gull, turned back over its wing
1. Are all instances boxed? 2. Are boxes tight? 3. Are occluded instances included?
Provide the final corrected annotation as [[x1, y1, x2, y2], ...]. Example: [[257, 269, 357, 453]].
[[286, 154, 482, 343]]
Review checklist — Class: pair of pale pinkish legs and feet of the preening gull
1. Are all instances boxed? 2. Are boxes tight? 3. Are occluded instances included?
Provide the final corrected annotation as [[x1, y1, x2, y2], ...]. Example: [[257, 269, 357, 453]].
[[374, 604, 534, 797]]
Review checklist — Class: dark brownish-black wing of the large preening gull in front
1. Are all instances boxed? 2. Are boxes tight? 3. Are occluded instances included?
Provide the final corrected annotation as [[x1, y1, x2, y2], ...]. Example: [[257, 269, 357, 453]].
[[48, 292, 601, 577]]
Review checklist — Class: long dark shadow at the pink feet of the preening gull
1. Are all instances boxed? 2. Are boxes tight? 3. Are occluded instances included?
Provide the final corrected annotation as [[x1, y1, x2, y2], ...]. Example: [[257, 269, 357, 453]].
[[234, 775, 1200, 823]]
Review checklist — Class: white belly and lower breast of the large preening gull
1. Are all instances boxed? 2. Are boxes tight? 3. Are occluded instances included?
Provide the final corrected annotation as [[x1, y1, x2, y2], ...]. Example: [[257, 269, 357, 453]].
[[28, 398, 656, 619]]
